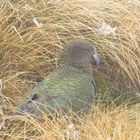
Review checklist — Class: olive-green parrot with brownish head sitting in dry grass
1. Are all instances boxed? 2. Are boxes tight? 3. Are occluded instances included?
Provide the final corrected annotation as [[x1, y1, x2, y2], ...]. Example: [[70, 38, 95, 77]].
[[15, 39, 99, 116]]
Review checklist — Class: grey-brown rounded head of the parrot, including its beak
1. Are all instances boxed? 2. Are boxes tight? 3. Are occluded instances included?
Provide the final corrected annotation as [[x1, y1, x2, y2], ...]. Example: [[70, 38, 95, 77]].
[[60, 39, 100, 71]]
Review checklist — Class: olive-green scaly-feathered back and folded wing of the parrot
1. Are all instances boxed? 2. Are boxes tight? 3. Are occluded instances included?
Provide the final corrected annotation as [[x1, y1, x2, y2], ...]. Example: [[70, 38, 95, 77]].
[[15, 67, 95, 114]]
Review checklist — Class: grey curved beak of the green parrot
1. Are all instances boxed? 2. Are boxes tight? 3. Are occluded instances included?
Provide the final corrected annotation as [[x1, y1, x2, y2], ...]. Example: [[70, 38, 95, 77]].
[[91, 48, 100, 68]]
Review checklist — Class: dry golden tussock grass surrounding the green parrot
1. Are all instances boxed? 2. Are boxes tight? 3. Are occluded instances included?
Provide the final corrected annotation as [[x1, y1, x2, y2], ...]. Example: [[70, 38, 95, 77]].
[[0, 0, 140, 140]]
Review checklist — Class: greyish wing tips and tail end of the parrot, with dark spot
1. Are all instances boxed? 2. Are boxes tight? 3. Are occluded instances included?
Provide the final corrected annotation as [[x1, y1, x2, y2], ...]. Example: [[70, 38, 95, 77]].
[[15, 83, 58, 115]]
